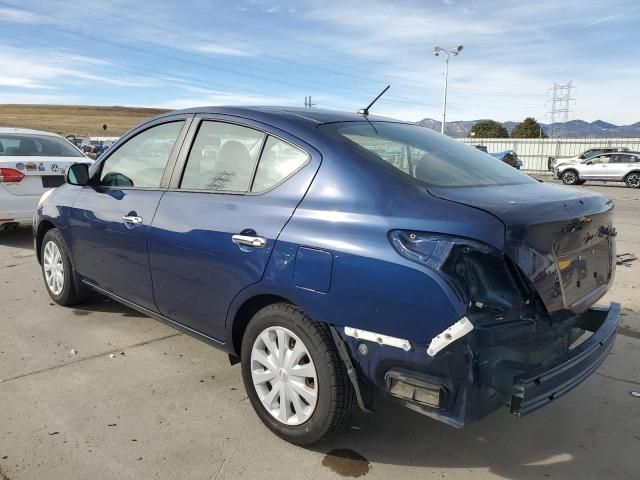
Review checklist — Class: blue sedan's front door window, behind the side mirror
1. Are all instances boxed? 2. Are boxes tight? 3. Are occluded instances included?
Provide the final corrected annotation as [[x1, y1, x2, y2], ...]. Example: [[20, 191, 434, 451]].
[[100, 121, 184, 188]]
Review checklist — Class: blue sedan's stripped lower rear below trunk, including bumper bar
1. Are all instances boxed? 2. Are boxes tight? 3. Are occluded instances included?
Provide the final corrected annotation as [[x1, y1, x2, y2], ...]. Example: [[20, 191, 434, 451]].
[[342, 303, 620, 428]]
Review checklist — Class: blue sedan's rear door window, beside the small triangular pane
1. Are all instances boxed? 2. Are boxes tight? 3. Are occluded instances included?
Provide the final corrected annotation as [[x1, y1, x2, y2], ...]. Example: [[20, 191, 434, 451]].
[[180, 121, 266, 193]]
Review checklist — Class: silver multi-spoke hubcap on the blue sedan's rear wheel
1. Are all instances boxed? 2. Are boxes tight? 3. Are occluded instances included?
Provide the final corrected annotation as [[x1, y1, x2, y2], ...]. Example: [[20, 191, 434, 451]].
[[251, 326, 318, 425]]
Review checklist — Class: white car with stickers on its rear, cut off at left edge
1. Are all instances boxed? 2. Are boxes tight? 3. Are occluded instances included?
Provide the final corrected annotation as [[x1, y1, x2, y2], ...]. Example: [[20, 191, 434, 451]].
[[0, 128, 93, 230]]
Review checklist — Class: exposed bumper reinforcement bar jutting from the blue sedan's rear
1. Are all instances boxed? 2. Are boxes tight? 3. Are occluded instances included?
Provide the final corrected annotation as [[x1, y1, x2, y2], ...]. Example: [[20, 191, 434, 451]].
[[511, 303, 620, 416]]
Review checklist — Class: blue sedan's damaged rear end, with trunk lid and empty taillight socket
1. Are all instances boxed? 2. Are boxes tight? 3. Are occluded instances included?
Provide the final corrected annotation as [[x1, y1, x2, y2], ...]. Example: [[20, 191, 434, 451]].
[[388, 187, 619, 426]]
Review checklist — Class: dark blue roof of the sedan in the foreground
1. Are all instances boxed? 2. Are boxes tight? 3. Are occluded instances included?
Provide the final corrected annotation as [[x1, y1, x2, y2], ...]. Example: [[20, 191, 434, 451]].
[[149, 106, 402, 125]]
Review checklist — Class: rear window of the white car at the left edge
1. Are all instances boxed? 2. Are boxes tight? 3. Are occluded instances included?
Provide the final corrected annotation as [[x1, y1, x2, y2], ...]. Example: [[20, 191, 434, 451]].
[[0, 134, 84, 157]]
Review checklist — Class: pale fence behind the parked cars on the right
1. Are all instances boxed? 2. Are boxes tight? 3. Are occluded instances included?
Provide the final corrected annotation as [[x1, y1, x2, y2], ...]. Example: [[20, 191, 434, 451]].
[[458, 138, 640, 173]]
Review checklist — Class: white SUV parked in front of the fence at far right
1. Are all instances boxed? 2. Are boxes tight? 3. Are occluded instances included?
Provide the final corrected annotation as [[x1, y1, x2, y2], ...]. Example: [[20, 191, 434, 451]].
[[554, 152, 640, 188]]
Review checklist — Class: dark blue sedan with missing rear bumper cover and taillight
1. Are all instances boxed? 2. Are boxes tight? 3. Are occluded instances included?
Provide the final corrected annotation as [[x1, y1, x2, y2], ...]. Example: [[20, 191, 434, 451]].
[[34, 107, 619, 445]]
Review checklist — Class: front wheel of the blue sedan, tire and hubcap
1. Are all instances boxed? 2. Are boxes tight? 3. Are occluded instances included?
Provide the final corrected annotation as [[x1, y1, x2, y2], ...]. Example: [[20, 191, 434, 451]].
[[40, 228, 84, 307]]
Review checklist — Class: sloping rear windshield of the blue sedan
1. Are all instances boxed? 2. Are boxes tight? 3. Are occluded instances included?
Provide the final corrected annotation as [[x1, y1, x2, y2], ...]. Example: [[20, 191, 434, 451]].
[[321, 122, 535, 187]]
